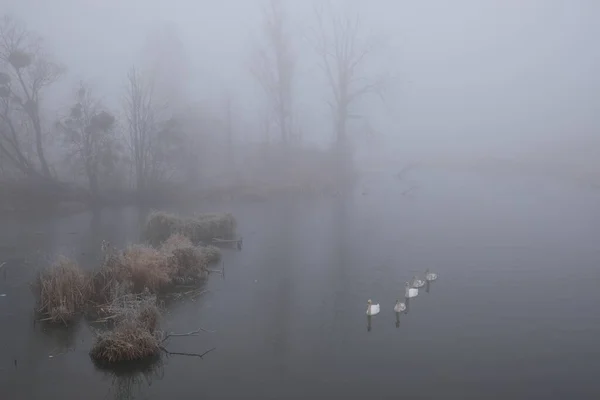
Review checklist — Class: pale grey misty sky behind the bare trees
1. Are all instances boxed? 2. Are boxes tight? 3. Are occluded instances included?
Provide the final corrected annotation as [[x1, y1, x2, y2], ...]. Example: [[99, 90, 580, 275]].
[[0, 0, 600, 165]]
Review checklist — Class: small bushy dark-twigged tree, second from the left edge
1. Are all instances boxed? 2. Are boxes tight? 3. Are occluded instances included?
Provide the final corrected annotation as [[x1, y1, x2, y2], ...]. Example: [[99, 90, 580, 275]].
[[57, 83, 116, 196]]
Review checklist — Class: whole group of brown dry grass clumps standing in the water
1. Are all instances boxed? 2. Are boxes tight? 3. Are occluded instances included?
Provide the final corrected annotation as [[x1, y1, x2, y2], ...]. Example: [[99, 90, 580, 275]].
[[35, 214, 227, 364]]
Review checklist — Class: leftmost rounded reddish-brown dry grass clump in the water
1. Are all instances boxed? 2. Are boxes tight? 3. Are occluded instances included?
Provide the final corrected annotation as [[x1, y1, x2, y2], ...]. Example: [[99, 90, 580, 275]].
[[36, 257, 88, 324]]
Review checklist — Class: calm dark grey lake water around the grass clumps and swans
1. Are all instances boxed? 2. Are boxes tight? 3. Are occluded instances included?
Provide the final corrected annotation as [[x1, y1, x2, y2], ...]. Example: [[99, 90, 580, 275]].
[[0, 167, 600, 400]]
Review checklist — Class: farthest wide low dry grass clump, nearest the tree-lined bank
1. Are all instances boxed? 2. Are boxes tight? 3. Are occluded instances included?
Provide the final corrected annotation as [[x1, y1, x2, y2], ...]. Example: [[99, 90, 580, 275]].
[[144, 211, 236, 246]]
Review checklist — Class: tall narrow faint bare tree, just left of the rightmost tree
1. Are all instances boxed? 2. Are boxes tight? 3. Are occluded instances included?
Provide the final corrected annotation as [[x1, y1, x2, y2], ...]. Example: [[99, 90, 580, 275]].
[[251, 0, 295, 144]]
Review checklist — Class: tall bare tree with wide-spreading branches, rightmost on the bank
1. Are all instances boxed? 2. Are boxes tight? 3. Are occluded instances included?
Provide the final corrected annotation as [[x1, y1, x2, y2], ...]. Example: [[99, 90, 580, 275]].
[[314, 4, 385, 147]]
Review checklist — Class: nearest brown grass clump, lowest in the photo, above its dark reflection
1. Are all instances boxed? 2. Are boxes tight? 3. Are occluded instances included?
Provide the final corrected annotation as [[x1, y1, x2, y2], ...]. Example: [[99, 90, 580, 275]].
[[90, 292, 161, 363]]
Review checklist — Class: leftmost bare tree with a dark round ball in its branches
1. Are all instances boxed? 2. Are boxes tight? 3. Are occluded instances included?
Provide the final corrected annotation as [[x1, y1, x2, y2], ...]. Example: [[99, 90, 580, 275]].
[[0, 16, 64, 178]]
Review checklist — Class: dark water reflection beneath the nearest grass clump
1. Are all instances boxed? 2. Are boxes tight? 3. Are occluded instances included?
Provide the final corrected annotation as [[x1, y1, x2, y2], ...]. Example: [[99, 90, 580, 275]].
[[94, 356, 164, 400]]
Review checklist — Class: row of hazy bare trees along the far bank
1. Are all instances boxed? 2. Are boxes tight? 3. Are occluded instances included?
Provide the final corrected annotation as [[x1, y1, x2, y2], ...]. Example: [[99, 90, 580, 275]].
[[0, 0, 385, 205]]
